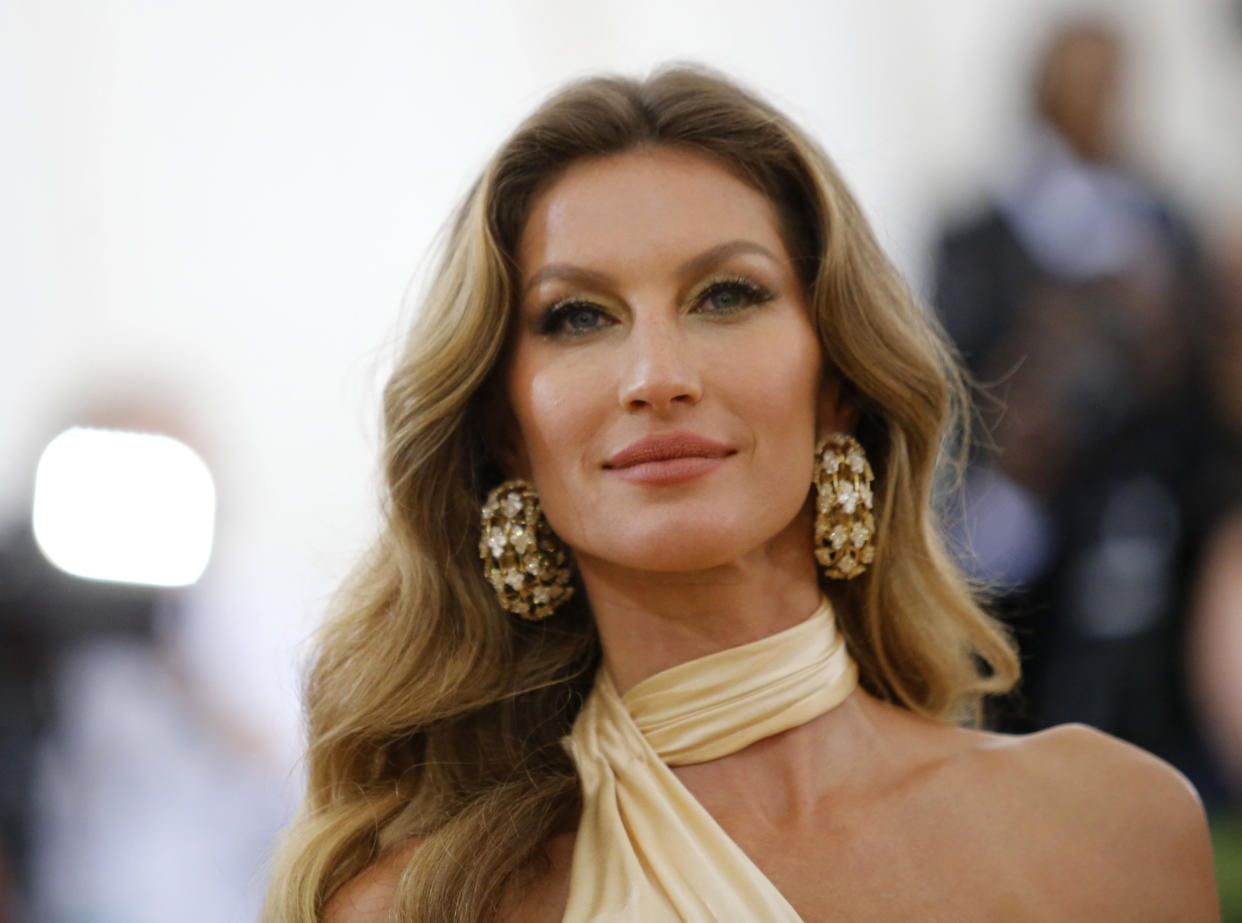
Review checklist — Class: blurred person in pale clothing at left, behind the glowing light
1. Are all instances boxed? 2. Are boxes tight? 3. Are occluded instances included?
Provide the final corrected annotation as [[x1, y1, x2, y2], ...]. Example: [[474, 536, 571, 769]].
[[0, 395, 293, 923]]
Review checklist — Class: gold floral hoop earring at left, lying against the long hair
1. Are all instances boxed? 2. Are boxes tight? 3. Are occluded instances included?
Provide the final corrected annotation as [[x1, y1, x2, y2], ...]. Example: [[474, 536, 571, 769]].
[[478, 481, 574, 621]]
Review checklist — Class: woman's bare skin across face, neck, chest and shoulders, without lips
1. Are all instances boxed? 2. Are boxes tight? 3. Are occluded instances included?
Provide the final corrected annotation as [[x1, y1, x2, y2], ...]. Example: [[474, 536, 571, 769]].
[[327, 147, 1220, 923]]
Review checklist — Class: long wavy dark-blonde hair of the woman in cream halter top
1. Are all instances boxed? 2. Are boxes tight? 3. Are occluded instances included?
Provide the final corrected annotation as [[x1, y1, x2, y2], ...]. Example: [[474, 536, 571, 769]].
[[263, 67, 1018, 923]]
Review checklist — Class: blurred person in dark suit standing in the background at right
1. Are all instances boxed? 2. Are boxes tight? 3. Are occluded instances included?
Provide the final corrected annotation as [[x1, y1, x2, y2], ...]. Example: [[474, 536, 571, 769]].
[[935, 21, 1222, 801]]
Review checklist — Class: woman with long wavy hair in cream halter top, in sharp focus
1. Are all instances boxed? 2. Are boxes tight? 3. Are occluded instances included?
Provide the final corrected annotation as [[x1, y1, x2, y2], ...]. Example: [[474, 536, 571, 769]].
[[267, 70, 1215, 923]]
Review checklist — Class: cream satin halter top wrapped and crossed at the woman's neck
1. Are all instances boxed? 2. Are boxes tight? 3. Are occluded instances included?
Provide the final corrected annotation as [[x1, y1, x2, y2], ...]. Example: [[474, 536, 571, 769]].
[[564, 600, 858, 923]]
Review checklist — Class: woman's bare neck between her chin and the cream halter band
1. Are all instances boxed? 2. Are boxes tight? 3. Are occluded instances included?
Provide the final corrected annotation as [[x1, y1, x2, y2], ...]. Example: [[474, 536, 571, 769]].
[[578, 504, 821, 693]]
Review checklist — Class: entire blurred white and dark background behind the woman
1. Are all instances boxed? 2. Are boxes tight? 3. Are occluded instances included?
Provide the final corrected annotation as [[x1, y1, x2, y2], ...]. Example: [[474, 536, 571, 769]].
[[0, 0, 1242, 923]]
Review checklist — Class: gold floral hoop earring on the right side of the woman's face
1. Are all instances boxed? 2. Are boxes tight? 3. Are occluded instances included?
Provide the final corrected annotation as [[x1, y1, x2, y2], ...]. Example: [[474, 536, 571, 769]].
[[815, 432, 876, 580]]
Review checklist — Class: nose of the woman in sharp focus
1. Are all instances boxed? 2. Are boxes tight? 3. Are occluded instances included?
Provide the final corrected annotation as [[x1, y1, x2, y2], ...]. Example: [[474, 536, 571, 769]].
[[620, 314, 703, 411]]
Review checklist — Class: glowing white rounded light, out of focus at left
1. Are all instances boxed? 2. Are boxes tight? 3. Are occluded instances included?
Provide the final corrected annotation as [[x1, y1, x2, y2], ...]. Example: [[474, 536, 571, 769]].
[[32, 427, 216, 586]]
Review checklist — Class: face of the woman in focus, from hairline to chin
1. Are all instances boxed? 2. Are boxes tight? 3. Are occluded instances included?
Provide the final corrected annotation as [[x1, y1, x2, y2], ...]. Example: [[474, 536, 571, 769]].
[[507, 147, 838, 571]]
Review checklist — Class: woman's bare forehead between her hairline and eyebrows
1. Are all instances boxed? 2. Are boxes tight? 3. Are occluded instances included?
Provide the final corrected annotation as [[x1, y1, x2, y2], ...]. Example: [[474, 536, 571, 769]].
[[518, 147, 787, 277]]
